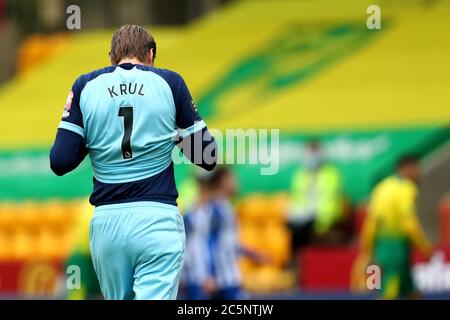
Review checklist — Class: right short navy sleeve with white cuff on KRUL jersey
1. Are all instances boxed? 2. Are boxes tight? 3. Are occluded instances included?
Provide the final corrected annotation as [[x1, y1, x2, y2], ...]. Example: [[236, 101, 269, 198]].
[[173, 75, 206, 138]]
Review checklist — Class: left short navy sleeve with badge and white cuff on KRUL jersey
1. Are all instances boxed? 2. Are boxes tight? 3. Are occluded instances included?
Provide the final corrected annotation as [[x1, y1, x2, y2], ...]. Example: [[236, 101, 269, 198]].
[[58, 78, 84, 138]]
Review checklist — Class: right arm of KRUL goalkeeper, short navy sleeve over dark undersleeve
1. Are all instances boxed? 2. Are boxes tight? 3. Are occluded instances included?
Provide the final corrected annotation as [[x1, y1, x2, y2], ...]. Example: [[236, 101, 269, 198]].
[[172, 75, 217, 170]]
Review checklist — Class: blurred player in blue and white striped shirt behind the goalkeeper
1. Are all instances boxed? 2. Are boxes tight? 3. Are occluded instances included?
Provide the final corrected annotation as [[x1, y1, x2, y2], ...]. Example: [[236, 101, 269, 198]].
[[184, 166, 270, 300]]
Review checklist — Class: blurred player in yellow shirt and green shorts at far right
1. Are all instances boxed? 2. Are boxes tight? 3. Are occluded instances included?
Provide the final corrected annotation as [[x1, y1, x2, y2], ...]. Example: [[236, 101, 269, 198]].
[[360, 156, 432, 299]]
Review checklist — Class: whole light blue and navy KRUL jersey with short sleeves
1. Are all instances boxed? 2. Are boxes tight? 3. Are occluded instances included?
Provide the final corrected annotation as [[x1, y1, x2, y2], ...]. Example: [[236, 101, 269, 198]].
[[59, 63, 206, 206]]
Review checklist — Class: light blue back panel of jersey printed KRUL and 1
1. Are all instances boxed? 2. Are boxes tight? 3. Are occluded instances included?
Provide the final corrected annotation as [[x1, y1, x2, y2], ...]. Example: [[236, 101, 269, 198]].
[[80, 66, 176, 183]]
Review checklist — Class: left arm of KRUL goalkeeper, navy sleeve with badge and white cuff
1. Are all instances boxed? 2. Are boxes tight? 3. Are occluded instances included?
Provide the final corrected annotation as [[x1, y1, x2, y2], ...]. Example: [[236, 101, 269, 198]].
[[50, 80, 88, 176]]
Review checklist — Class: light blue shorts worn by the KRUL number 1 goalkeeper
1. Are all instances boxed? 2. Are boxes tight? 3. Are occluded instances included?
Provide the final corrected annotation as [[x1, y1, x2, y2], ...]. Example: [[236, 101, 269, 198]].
[[89, 202, 186, 300]]
